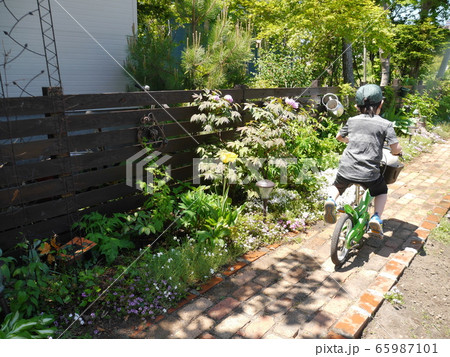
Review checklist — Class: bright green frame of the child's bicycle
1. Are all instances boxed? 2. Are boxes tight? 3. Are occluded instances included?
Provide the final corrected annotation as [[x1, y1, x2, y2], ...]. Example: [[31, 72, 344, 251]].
[[344, 187, 373, 249]]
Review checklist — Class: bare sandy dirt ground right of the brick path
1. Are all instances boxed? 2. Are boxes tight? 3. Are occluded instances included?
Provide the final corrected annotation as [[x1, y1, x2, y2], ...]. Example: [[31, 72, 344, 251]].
[[362, 225, 450, 339]]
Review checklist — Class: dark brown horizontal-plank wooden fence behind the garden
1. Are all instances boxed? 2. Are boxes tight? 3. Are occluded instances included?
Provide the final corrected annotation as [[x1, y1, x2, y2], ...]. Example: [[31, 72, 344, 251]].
[[0, 87, 410, 249]]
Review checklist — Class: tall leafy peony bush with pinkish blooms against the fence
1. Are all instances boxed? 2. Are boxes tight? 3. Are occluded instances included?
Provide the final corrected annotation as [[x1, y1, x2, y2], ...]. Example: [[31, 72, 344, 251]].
[[191, 91, 340, 197]]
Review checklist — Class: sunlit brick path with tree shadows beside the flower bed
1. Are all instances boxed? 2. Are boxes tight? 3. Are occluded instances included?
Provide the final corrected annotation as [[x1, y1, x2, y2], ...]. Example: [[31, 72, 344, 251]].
[[127, 142, 450, 339]]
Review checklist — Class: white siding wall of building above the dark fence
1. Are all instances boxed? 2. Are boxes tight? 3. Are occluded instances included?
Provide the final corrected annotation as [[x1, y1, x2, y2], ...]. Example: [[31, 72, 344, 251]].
[[0, 0, 137, 97]]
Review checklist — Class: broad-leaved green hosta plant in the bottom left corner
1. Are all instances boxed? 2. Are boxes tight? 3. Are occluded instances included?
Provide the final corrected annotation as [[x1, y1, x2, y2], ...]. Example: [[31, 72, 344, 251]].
[[0, 311, 56, 339]]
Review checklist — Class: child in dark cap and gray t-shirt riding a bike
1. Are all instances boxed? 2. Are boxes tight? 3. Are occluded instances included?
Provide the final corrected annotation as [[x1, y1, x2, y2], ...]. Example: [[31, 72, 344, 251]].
[[324, 84, 402, 234]]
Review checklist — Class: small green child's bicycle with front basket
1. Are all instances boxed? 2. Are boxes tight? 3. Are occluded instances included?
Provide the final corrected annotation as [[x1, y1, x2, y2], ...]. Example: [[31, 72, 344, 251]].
[[330, 148, 403, 266]]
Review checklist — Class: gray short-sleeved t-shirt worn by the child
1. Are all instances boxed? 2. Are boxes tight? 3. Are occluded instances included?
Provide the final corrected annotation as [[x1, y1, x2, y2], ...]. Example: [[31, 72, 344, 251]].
[[338, 114, 398, 182]]
